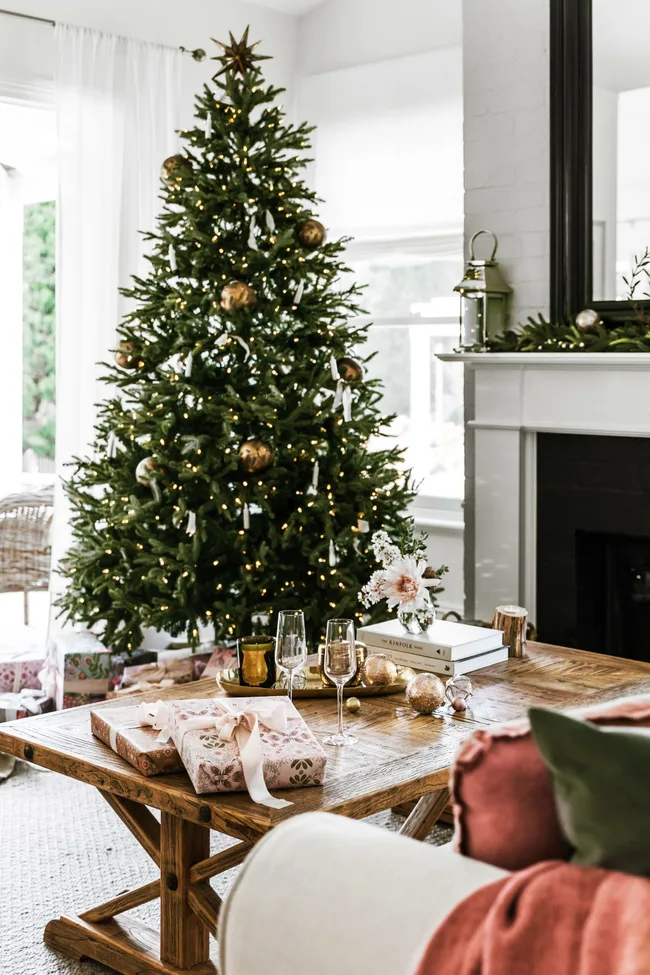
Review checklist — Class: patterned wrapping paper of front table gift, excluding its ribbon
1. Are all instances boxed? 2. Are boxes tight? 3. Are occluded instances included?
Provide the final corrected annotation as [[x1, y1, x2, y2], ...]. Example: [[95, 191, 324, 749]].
[[160, 695, 327, 795]]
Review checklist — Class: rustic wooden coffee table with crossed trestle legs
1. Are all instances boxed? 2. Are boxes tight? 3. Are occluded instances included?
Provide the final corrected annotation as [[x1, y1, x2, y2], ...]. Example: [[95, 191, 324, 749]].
[[0, 644, 650, 975]]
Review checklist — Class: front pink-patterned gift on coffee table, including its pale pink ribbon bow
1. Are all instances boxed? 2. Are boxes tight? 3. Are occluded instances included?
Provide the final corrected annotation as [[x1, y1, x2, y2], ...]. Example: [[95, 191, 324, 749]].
[[139, 696, 327, 808]]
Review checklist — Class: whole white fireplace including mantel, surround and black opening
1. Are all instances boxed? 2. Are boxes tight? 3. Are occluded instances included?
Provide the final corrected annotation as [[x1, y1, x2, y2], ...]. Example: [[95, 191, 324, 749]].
[[439, 350, 650, 659]]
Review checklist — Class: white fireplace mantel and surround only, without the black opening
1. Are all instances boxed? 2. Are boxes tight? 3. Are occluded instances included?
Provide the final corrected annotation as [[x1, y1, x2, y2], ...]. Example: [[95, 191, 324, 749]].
[[438, 352, 650, 621]]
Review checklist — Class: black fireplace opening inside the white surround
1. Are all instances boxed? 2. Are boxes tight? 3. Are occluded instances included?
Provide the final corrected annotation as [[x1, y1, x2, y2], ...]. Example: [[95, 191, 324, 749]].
[[537, 434, 650, 661]]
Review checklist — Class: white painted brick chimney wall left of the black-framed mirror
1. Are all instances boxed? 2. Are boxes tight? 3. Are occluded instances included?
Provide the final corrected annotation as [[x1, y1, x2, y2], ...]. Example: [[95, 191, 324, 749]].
[[463, 0, 550, 324]]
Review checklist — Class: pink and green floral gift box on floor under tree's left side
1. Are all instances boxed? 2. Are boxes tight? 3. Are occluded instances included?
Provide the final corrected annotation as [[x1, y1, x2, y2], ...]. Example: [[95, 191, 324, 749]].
[[40, 632, 113, 709]]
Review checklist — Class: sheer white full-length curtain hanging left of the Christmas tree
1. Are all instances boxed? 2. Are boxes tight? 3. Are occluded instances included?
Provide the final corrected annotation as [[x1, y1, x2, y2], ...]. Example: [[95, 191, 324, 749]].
[[52, 24, 183, 624]]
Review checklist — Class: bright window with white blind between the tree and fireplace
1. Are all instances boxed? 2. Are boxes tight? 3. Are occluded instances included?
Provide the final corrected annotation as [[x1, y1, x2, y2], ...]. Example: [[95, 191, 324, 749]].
[[299, 48, 463, 506]]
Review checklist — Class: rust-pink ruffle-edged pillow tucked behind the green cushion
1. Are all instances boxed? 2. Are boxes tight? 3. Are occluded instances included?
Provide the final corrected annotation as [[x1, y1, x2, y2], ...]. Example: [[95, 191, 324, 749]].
[[452, 694, 650, 870]]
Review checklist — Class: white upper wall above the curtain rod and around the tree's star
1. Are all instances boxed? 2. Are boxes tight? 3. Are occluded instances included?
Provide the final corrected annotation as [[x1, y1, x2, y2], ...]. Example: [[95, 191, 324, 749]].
[[0, 0, 297, 124]]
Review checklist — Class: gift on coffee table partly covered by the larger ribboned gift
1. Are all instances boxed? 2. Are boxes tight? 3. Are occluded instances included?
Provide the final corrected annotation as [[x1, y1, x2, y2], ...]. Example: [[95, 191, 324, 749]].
[[90, 704, 183, 775]]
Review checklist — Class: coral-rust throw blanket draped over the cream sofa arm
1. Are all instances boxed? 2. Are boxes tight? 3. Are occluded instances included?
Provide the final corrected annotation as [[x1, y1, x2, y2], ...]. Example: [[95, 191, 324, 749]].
[[416, 861, 650, 975]]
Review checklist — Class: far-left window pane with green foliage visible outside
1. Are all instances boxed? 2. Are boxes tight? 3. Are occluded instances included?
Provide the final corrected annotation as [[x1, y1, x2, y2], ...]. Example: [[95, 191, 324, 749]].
[[0, 99, 56, 493]]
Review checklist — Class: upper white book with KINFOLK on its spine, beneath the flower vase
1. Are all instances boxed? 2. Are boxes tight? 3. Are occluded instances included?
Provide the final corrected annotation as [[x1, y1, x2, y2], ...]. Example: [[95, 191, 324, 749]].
[[357, 619, 503, 660]]
